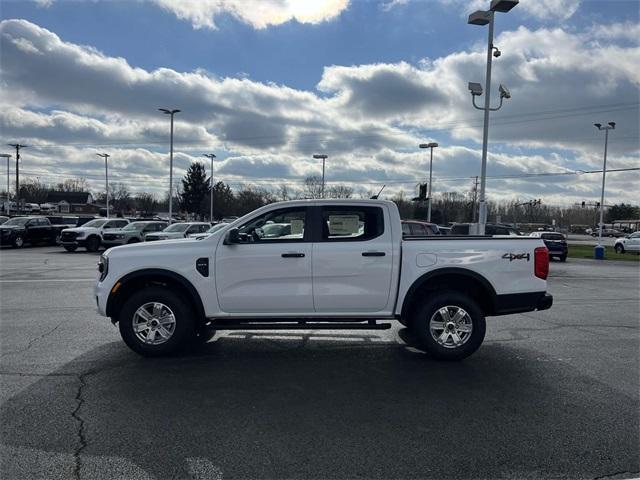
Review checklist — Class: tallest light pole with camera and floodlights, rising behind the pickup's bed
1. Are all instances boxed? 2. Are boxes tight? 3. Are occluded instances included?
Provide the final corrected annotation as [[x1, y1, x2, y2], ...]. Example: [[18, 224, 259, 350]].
[[467, 0, 518, 235]]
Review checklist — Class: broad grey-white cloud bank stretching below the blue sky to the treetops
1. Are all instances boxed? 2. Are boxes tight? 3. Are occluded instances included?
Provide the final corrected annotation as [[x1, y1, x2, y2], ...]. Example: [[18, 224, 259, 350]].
[[0, 20, 640, 203]]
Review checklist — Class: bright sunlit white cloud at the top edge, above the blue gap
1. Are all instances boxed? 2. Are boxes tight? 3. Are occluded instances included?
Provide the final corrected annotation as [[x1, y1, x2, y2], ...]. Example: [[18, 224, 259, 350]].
[[153, 0, 350, 29]]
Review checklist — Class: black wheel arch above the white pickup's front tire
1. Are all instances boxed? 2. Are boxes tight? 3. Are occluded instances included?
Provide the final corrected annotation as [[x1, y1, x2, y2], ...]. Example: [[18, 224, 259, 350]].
[[106, 268, 205, 322]]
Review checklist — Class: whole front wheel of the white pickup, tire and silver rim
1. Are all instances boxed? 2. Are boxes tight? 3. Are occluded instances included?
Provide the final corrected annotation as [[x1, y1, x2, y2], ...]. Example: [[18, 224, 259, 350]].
[[118, 287, 195, 357]]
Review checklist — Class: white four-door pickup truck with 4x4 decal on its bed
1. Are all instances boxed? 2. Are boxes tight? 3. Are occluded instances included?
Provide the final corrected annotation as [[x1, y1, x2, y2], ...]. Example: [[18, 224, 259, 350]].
[[95, 200, 553, 360]]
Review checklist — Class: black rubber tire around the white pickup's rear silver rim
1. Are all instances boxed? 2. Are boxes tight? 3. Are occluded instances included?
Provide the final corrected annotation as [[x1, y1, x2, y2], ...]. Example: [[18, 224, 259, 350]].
[[409, 291, 486, 360]]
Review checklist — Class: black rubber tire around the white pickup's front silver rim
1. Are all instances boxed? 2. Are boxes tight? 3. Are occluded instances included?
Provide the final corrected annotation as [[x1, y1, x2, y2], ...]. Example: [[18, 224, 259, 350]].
[[118, 287, 196, 357]]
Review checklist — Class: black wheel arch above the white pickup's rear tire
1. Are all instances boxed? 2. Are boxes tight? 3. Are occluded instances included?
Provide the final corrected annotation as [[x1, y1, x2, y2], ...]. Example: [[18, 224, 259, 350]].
[[400, 267, 496, 318]]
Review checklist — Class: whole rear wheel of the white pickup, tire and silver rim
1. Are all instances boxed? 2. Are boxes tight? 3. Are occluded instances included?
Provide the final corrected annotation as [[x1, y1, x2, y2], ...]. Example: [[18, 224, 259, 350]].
[[409, 291, 486, 360]]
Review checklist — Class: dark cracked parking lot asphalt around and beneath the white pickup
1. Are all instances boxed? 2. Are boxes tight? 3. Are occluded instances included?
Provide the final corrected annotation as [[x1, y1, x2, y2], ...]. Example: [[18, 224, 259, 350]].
[[0, 247, 640, 479]]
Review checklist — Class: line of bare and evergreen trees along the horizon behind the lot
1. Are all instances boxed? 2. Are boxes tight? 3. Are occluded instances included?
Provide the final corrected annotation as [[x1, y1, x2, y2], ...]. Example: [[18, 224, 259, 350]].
[[2, 162, 640, 226]]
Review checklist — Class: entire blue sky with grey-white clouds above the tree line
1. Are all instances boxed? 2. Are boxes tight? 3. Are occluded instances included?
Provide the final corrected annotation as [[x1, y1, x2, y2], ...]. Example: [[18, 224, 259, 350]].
[[0, 0, 640, 205]]
